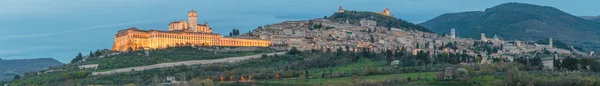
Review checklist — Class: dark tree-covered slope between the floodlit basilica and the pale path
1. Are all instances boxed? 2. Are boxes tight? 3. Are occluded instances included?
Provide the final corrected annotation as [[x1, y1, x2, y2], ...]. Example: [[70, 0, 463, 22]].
[[71, 47, 275, 71]]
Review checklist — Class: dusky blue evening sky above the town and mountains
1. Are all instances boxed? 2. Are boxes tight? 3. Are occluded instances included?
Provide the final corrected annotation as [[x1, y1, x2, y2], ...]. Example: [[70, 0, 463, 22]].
[[0, 0, 600, 63]]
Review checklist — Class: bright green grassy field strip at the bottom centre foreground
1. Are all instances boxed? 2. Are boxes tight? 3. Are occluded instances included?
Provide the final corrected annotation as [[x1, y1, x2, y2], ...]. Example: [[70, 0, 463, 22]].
[[259, 72, 440, 85]]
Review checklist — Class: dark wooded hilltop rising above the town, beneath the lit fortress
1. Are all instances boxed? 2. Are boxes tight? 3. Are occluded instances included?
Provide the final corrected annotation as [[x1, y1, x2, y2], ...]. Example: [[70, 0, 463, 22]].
[[327, 11, 431, 32]]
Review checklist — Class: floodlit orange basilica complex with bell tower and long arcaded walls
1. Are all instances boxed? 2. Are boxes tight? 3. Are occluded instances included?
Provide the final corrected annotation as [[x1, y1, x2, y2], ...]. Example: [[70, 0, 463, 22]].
[[112, 10, 271, 51]]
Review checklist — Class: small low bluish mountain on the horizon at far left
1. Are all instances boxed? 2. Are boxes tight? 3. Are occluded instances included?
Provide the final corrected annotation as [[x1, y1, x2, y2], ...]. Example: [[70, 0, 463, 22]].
[[0, 58, 63, 81]]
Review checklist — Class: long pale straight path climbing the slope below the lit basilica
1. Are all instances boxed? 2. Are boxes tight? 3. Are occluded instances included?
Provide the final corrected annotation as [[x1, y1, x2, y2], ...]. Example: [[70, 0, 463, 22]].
[[92, 52, 285, 75]]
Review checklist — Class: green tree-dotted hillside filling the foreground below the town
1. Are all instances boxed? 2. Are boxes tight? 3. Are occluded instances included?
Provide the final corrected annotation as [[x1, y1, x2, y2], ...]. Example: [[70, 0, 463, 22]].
[[10, 48, 600, 86]]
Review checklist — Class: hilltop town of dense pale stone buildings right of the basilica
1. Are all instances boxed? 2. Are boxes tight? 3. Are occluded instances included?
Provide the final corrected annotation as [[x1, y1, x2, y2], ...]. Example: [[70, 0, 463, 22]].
[[245, 6, 593, 68]]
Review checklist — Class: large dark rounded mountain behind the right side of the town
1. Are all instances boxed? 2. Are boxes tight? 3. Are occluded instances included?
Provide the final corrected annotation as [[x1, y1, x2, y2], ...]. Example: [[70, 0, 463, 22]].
[[419, 3, 600, 50]]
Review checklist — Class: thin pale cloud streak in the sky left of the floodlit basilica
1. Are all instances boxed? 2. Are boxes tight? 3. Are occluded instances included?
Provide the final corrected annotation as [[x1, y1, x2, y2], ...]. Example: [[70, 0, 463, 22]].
[[0, 20, 156, 40]]
